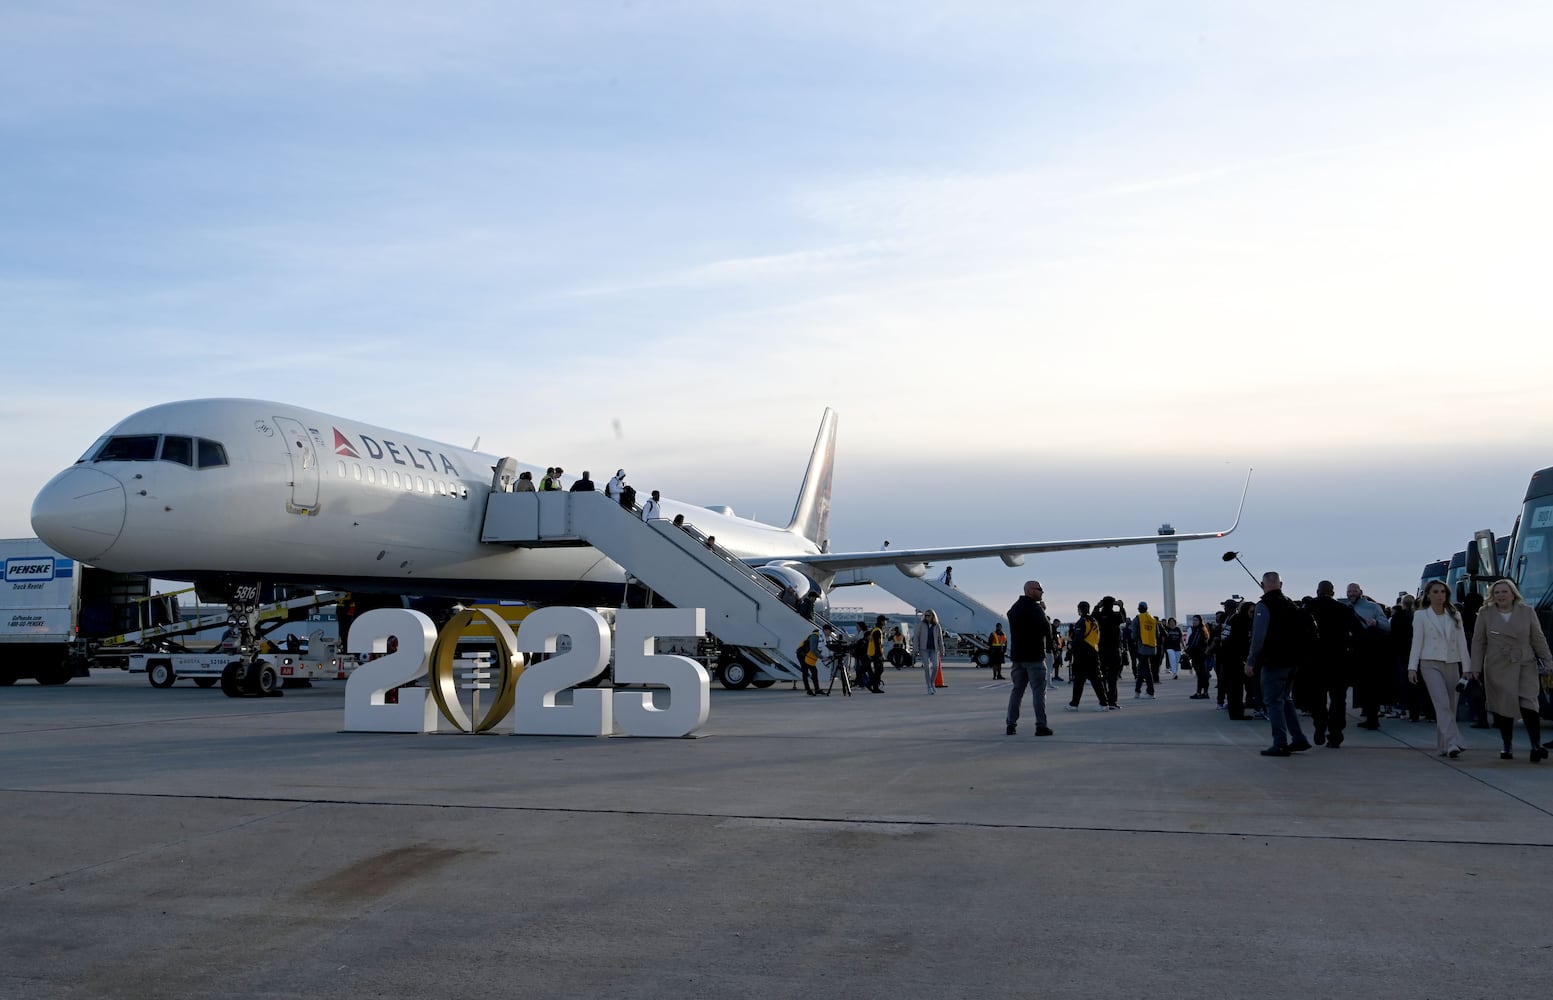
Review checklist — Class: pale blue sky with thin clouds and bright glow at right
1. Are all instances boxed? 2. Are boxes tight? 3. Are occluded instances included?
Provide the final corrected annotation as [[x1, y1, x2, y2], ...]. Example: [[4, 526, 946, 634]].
[[0, 0, 1553, 616]]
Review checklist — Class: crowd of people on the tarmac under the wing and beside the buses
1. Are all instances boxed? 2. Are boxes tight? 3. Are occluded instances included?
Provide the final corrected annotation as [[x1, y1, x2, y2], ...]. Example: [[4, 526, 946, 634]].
[[988, 573, 1553, 764]]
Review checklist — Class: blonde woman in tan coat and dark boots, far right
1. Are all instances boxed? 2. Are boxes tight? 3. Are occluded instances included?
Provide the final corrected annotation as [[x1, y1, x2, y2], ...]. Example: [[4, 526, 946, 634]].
[[1472, 579, 1553, 764]]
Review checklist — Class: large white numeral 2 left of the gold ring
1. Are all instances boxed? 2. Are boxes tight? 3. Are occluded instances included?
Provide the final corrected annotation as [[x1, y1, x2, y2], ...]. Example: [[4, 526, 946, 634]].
[[345, 607, 439, 733]]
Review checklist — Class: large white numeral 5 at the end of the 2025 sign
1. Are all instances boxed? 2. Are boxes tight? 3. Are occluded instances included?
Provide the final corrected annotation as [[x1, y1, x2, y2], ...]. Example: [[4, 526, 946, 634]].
[[615, 607, 711, 736]]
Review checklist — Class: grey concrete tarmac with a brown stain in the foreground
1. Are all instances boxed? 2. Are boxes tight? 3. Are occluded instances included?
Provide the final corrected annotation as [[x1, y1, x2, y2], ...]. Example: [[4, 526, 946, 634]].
[[0, 665, 1553, 1000]]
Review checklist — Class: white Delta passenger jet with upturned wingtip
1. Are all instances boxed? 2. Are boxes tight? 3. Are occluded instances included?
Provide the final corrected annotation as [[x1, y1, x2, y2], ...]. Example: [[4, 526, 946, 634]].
[[33, 399, 1250, 607]]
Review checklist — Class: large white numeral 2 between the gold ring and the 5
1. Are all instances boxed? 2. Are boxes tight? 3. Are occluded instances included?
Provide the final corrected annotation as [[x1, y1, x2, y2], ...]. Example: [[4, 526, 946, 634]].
[[512, 607, 615, 736]]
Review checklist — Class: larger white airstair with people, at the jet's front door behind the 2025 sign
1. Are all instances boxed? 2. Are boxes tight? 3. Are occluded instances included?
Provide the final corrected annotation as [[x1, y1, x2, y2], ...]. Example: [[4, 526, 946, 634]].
[[480, 491, 825, 680]]
